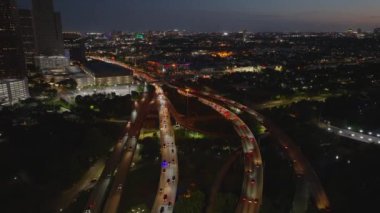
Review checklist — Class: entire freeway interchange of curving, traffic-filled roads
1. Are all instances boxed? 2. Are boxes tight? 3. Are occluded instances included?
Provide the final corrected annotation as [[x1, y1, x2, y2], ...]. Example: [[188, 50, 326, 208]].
[[81, 57, 330, 213]]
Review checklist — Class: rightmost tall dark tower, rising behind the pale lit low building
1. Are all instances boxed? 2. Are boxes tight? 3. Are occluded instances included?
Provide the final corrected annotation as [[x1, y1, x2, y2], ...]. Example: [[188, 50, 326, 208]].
[[32, 0, 64, 56]]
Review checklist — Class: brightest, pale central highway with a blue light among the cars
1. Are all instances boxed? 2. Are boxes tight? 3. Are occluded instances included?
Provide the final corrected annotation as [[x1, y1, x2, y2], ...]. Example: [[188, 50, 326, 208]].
[[152, 84, 178, 213]]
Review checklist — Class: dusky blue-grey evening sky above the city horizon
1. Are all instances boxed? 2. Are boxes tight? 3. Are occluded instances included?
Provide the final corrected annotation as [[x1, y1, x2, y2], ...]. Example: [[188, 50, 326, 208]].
[[18, 0, 380, 32]]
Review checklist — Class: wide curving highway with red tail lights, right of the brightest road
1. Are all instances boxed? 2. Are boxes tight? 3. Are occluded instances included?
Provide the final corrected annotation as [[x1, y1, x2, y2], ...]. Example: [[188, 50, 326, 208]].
[[198, 97, 264, 213]]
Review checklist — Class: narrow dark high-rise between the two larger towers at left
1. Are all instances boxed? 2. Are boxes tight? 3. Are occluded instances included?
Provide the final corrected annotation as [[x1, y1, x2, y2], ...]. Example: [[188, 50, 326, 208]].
[[19, 9, 36, 69]]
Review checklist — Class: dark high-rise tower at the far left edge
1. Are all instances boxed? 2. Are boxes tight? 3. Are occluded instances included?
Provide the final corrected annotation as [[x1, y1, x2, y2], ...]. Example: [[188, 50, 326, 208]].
[[0, 0, 26, 79]]
